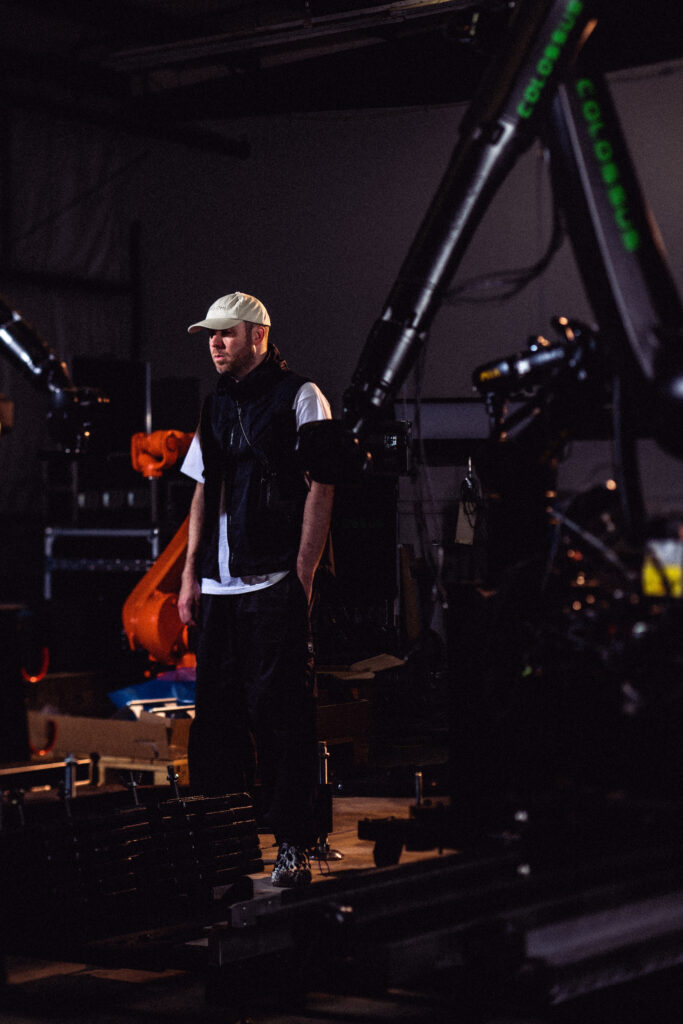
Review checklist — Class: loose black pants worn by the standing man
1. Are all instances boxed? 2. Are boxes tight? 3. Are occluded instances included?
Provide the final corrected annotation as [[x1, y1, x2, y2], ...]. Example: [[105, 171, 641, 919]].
[[188, 572, 317, 846]]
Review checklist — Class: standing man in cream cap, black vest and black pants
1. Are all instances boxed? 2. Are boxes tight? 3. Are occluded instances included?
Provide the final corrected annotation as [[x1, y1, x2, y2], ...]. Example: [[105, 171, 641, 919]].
[[178, 292, 334, 886]]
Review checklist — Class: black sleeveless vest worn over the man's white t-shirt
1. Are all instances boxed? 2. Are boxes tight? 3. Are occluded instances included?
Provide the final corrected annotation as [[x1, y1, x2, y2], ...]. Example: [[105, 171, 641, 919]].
[[199, 346, 308, 580]]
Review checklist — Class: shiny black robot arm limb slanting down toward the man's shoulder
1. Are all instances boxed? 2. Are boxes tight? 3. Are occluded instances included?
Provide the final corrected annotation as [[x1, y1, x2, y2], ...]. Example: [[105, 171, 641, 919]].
[[344, 0, 591, 437]]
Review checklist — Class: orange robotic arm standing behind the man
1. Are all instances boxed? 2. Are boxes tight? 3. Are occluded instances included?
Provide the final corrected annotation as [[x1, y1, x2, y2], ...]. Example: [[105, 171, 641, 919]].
[[122, 430, 195, 666]]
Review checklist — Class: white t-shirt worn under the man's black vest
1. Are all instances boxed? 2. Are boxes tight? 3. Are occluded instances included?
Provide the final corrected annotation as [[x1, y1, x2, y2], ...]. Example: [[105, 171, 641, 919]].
[[180, 381, 332, 594]]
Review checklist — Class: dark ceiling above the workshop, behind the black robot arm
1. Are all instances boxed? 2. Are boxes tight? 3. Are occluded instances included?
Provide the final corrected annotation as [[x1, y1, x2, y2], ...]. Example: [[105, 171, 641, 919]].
[[0, 0, 683, 155]]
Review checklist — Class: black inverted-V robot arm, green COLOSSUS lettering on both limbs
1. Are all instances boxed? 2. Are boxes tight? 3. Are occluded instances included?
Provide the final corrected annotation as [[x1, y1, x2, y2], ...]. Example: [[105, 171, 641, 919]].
[[343, 0, 683, 457]]
